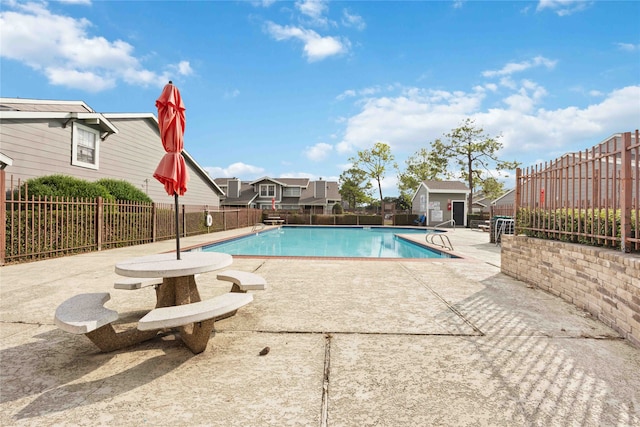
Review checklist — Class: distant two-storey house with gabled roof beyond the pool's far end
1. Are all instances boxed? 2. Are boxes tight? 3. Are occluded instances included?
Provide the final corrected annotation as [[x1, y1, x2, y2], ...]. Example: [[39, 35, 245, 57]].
[[215, 176, 341, 214]]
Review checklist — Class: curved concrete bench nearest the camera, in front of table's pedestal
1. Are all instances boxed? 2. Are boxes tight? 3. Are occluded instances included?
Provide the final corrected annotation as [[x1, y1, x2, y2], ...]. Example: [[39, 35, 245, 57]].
[[138, 293, 253, 354]]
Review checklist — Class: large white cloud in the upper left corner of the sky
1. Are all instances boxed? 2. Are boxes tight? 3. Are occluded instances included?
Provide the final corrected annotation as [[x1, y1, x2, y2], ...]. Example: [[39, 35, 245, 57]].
[[0, 3, 192, 92]]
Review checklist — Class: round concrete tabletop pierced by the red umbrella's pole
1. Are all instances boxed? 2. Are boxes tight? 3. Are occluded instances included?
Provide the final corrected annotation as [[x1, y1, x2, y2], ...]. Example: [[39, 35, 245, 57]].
[[115, 252, 233, 278]]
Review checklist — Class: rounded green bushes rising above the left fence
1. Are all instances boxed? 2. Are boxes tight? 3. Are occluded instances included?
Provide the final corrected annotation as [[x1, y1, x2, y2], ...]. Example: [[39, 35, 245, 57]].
[[20, 175, 114, 200]]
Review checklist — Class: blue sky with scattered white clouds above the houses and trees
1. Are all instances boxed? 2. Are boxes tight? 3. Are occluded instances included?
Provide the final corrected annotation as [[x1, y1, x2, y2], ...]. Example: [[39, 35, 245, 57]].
[[0, 0, 640, 196]]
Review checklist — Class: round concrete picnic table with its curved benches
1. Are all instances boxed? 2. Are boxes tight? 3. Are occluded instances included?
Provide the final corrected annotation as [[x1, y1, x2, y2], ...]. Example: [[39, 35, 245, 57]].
[[55, 252, 253, 353]]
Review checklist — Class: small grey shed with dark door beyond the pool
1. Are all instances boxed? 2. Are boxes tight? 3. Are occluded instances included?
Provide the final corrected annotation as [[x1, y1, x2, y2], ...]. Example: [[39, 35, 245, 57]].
[[411, 180, 470, 227]]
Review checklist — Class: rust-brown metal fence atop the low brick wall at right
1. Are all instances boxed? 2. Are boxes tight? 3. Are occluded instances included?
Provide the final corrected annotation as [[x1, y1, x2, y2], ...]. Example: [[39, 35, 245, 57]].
[[515, 130, 640, 253]]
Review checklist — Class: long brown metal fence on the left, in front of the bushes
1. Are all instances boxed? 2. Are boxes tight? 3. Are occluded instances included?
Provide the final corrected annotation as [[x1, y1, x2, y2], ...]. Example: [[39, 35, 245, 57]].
[[0, 171, 262, 265]]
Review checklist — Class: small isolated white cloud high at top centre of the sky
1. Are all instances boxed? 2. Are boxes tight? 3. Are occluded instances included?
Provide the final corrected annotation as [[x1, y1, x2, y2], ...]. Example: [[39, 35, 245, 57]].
[[266, 22, 350, 62]]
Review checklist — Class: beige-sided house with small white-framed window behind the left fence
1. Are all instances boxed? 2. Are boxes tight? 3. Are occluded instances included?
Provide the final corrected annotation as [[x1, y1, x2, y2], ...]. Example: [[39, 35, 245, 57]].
[[0, 98, 223, 208]]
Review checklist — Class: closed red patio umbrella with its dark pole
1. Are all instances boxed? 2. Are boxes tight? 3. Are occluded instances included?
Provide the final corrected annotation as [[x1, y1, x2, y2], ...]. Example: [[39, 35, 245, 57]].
[[153, 82, 189, 259]]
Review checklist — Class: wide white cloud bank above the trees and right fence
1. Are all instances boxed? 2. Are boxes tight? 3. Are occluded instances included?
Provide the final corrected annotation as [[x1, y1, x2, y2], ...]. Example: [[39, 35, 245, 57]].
[[335, 80, 640, 167]]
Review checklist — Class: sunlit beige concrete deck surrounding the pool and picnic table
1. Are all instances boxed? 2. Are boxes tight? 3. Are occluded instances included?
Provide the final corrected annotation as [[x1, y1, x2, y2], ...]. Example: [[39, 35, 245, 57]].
[[0, 229, 640, 426]]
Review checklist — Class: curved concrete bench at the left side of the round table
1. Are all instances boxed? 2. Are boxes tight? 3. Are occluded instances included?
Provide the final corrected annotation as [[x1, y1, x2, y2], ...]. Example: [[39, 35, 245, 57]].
[[54, 292, 158, 351]]
